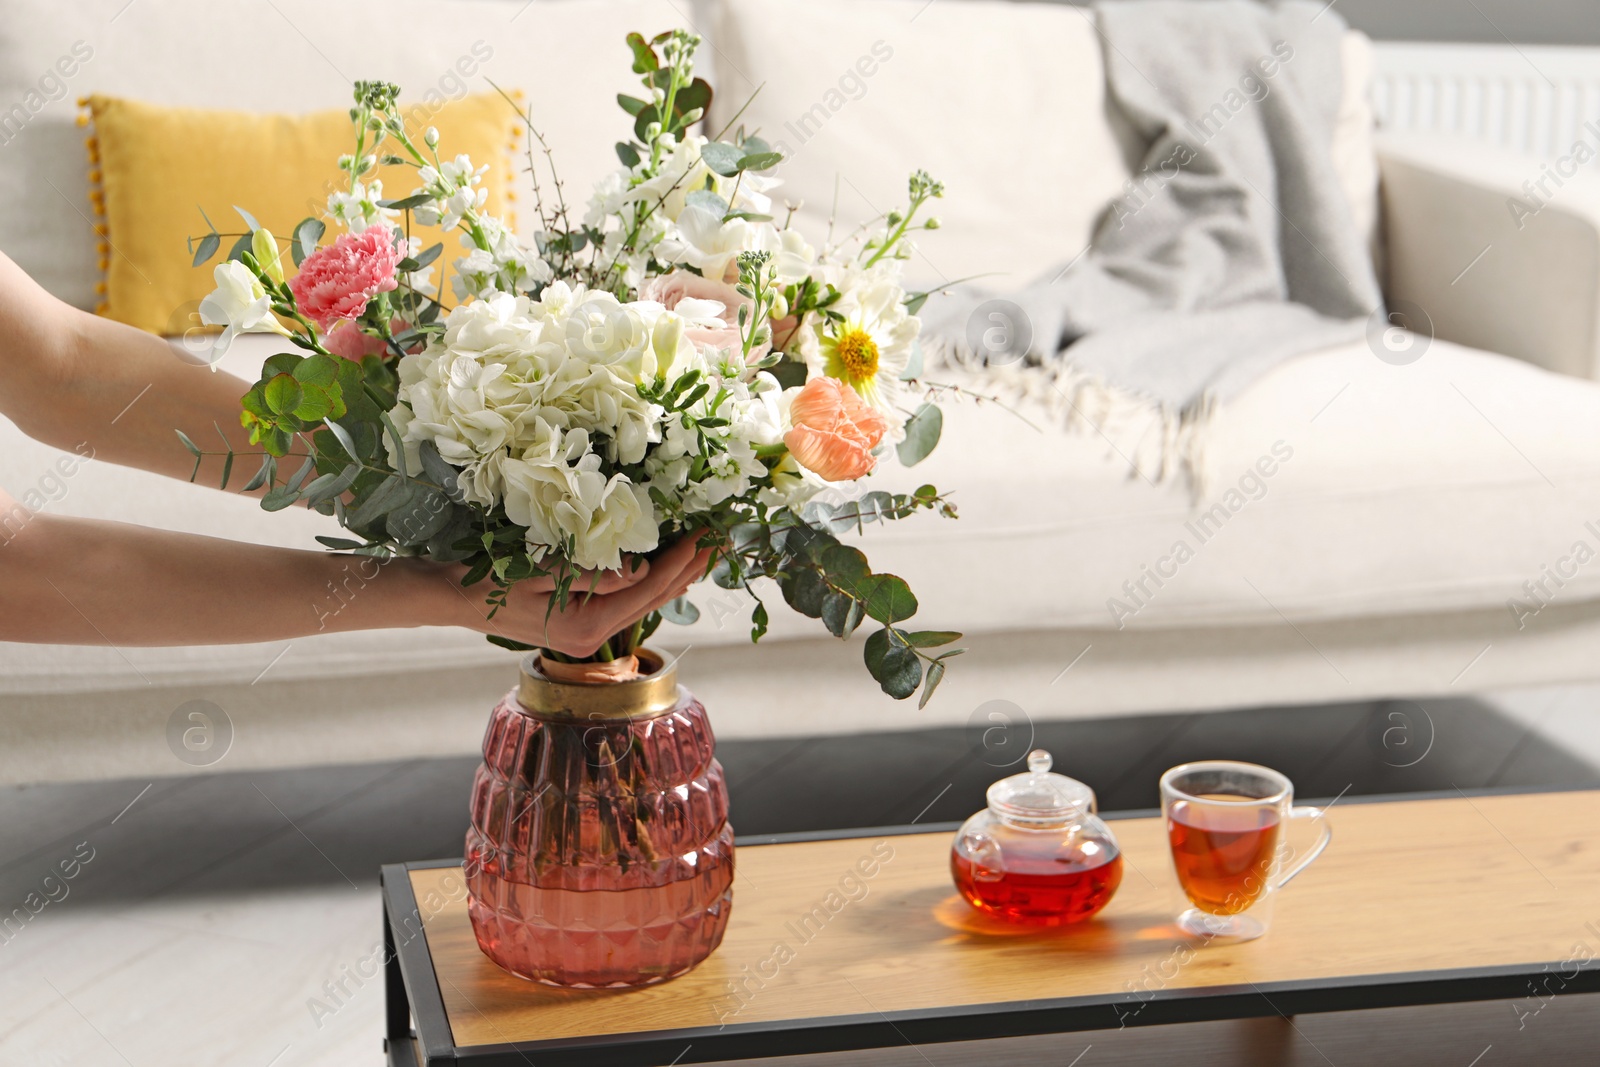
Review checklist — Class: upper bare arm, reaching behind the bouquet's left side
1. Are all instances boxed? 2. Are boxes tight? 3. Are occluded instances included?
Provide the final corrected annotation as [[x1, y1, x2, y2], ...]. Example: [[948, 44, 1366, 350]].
[[0, 253, 259, 486]]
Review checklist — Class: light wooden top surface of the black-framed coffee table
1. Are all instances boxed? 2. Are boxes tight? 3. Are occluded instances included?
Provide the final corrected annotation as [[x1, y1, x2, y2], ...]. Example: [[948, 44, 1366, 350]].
[[408, 790, 1600, 1046]]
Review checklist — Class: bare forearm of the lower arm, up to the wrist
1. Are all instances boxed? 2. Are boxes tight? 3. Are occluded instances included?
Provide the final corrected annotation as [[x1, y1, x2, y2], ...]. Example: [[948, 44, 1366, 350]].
[[0, 507, 464, 646]]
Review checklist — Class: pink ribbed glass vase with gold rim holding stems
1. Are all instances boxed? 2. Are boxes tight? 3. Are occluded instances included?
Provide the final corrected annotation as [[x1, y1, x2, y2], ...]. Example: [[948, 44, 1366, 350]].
[[466, 649, 733, 989]]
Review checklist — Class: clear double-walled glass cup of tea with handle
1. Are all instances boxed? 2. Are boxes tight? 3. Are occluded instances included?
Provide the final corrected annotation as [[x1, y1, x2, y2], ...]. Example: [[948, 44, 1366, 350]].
[[1162, 760, 1333, 941]]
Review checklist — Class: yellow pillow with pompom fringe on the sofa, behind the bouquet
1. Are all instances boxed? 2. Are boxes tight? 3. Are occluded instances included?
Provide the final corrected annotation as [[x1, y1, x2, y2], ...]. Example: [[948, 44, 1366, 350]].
[[85, 94, 520, 334]]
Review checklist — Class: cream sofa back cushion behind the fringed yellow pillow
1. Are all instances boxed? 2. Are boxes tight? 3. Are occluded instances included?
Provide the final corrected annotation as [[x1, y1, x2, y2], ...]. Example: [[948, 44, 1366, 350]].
[[0, 0, 709, 307]]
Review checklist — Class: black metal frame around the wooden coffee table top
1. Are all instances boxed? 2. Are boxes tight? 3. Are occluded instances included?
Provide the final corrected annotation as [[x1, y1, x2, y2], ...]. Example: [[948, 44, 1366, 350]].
[[382, 787, 1600, 1067]]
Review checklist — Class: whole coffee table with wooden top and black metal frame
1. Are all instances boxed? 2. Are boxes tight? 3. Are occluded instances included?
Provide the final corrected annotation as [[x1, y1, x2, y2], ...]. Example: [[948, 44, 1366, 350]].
[[382, 790, 1600, 1067]]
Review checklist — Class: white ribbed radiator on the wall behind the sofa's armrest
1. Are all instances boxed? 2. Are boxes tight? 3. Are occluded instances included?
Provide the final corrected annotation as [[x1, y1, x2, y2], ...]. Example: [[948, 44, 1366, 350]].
[[1373, 42, 1600, 158]]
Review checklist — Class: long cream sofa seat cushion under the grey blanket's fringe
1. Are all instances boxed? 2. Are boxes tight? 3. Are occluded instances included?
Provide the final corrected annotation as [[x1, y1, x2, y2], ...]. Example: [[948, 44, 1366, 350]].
[[0, 336, 1600, 693]]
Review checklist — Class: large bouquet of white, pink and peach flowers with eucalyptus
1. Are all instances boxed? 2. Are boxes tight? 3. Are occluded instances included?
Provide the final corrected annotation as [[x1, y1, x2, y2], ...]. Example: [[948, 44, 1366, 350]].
[[184, 30, 962, 702]]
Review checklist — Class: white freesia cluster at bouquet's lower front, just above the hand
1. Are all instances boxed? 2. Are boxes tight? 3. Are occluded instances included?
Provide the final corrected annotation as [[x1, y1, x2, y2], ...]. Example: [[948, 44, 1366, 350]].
[[501, 419, 659, 569]]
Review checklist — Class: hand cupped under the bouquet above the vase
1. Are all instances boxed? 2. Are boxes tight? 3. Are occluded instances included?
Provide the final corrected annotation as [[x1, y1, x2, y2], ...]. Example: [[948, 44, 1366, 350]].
[[461, 534, 714, 657]]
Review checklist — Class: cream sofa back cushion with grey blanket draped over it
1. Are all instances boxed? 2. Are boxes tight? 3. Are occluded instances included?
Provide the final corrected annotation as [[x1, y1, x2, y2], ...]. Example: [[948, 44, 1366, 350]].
[[710, 0, 1378, 290]]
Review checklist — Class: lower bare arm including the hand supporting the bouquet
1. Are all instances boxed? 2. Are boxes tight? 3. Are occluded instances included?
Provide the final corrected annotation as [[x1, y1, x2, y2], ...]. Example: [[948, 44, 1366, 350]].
[[0, 493, 707, 656]]
